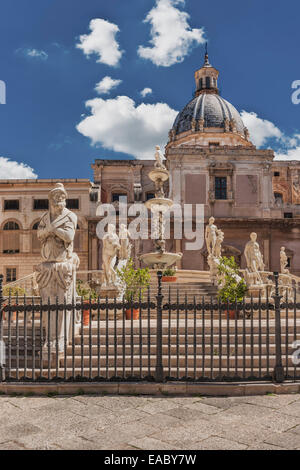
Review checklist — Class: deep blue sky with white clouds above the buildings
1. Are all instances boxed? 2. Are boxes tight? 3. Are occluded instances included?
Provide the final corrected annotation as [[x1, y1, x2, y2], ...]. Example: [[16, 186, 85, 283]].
[[0, 0, 300, 178]]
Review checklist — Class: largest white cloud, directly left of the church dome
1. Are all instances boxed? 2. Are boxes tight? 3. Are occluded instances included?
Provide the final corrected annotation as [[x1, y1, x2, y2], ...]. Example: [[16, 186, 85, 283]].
[[77, 96, 177, 159]]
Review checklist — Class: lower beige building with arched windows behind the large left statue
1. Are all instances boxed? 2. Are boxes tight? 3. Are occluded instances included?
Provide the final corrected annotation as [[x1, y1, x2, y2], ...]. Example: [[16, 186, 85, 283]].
[[0, 179, 92, 283]]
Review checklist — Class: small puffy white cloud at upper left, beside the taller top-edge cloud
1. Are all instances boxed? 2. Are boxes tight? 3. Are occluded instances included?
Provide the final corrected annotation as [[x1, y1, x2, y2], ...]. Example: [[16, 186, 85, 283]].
[[76, 18, 123, 66]]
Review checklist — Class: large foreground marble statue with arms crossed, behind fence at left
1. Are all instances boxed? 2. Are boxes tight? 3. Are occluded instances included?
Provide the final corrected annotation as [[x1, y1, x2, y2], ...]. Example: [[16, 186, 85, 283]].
[[36, 183, 79, 353]]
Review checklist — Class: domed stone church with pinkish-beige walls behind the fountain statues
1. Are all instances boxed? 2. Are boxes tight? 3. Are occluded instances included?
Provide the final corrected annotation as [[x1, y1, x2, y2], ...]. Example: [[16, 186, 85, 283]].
[[86, 55, 300, 275]]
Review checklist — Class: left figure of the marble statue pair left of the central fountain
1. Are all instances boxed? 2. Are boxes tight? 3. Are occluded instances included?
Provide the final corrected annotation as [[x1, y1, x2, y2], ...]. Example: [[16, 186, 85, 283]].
[[102, 224, 121, 288]]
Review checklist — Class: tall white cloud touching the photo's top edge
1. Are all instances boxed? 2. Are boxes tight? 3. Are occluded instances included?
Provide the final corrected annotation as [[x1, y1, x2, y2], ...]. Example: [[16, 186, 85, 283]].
[[138, 0, 205, 67]]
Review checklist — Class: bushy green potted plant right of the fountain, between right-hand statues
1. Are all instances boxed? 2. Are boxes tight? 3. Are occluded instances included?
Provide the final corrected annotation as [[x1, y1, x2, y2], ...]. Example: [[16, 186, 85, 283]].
[[218, 256, 247, 319]]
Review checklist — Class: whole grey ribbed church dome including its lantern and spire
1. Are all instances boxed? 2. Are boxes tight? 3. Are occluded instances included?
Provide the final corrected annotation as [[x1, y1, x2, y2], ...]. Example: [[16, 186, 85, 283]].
[[169, 51, 252, 145]]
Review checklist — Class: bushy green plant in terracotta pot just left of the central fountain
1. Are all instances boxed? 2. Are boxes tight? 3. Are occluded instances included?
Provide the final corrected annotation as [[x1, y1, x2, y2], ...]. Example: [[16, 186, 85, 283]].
[[117, 258, 151, 320]]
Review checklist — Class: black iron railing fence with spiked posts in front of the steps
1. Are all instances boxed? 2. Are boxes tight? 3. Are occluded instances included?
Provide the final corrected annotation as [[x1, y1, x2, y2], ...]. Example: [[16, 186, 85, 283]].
[[0, 272, 300, 382]]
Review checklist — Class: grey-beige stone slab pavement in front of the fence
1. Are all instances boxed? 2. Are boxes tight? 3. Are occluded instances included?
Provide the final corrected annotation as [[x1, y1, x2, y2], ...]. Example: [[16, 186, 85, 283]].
[[0, 394, 300, 450]]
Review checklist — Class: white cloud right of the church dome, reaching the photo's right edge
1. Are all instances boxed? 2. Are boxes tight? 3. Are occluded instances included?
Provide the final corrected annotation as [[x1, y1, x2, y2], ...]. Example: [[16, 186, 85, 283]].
[[241, 111, 300, 160]]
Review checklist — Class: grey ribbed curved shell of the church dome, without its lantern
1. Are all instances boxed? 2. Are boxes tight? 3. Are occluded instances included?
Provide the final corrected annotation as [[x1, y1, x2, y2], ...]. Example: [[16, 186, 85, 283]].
[[173, 92, 245, 134]]
